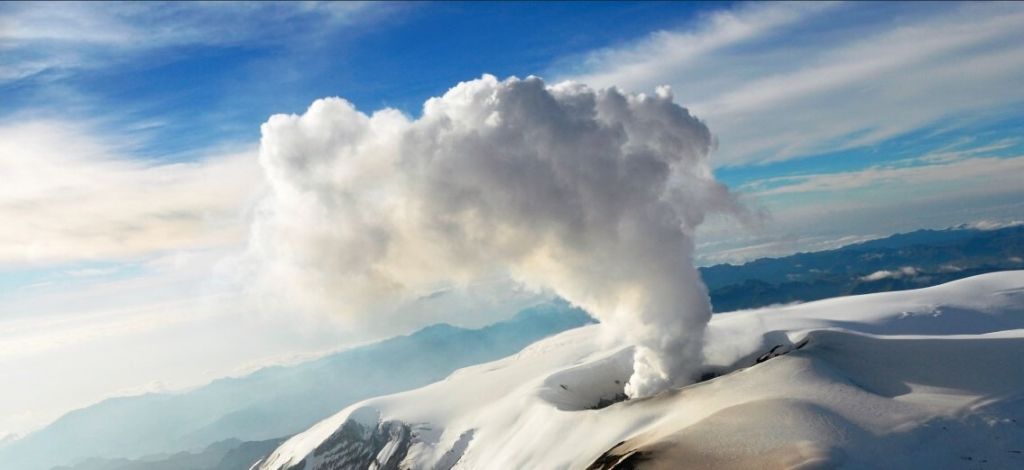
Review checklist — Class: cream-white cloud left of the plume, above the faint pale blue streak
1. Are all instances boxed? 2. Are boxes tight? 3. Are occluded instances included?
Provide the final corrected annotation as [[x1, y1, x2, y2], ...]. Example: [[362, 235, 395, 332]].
[[0, 121, 262, 266]]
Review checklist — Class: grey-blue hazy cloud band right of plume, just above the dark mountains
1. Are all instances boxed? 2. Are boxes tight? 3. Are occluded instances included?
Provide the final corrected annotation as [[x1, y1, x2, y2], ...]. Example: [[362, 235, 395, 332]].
[[698, 151, 1024, 264]]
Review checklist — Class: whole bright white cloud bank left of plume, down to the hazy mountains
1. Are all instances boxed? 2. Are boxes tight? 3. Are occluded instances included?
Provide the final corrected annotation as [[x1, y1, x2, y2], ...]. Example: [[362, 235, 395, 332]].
[[0, 119, 272, 434]]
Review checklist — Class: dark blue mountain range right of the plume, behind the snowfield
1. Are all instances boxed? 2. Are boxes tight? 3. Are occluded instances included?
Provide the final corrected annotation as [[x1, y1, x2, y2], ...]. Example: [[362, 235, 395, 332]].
[[700, 225, 1024, 311]]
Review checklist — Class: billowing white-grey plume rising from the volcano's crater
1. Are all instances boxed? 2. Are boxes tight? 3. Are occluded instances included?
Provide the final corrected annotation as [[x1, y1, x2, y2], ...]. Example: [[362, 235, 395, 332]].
[[250, 76, 737, 396]]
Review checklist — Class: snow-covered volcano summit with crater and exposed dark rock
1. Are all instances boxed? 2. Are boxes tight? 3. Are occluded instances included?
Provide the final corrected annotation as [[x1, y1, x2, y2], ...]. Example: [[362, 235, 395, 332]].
[[254, 271, 1024, 470]]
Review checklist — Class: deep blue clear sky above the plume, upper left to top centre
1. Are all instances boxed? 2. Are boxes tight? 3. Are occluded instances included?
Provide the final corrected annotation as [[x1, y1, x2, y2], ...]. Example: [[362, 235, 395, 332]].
[[0, 2, 715, 158]]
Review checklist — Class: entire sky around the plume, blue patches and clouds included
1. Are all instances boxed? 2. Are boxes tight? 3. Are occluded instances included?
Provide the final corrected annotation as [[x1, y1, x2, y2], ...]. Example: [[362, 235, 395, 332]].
[[0, 2, 1024, 436]]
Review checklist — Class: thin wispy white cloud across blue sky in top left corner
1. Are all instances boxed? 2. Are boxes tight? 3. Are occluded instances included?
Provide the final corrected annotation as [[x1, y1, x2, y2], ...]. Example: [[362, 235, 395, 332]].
[[0, 2, 391, 83]]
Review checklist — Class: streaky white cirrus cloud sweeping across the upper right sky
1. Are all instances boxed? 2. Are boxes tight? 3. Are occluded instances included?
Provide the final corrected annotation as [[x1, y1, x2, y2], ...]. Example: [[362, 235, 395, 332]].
[[560, 2, 1024, 166]]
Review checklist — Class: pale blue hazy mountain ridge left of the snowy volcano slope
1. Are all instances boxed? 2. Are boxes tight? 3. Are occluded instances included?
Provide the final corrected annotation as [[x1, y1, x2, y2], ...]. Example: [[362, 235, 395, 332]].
[[0, 301, 593, 470]]
